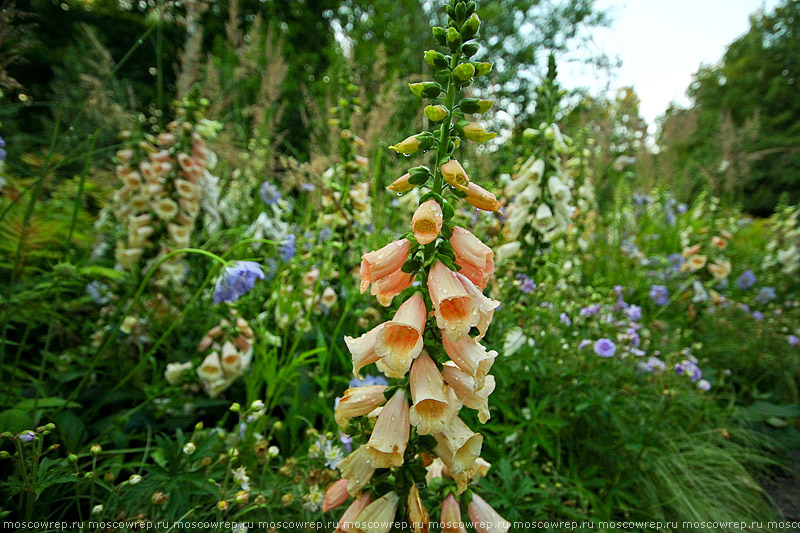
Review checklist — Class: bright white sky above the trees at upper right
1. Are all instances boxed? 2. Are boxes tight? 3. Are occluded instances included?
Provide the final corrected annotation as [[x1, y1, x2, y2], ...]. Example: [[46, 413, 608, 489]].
[[559, 0, 779, 131]]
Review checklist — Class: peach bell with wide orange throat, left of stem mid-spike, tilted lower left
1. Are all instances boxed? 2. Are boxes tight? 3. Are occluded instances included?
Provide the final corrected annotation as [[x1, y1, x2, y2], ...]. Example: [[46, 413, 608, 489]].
[[375, 292, 428, 378]]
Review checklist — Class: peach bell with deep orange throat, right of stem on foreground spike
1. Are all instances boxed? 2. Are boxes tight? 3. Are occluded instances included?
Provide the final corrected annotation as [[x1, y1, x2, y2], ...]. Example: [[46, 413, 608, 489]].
[[428, 261, 480, 340]]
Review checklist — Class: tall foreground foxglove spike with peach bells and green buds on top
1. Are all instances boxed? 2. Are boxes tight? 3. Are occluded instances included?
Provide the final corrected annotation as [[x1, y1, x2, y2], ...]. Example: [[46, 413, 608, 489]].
[[329, 0, 510, 532]]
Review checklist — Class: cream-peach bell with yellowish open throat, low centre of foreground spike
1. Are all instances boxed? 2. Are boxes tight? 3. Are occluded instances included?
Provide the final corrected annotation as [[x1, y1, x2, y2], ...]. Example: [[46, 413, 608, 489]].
[[409, 351, 461, 435]]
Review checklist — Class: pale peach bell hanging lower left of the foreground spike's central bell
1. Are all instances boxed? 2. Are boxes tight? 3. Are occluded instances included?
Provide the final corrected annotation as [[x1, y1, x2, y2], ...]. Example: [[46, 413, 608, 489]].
[[366, 389, 410, 466]]
